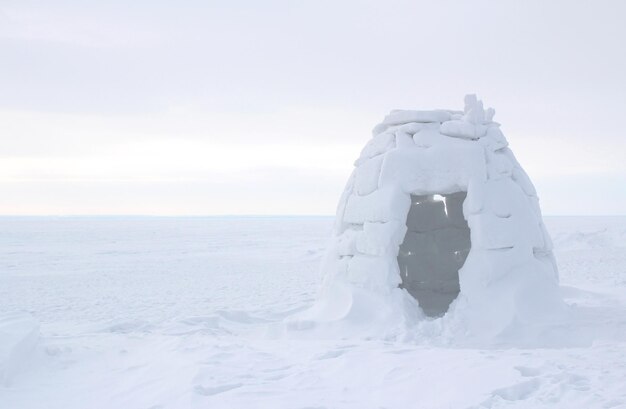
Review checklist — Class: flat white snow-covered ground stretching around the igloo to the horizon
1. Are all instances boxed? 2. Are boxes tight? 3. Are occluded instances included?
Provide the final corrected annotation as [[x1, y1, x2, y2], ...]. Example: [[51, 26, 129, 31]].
[[0, 217, 626, 409]]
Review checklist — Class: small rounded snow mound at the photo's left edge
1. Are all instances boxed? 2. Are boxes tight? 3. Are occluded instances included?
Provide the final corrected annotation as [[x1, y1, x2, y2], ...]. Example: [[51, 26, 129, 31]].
[[0, 313, 39, 385]]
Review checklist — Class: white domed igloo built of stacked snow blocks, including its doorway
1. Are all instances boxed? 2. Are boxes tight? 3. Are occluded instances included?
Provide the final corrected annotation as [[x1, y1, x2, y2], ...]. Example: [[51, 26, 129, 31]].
[[288, 95, 562, 339]]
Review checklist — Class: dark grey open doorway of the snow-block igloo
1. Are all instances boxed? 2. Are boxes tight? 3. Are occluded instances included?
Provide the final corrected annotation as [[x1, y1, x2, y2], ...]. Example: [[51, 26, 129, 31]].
[[398, 192, 471, 317]]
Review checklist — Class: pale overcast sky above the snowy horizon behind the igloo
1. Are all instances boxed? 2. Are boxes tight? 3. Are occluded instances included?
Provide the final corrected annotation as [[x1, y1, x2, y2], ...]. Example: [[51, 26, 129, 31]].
[[0, 0, 626, 215]]
